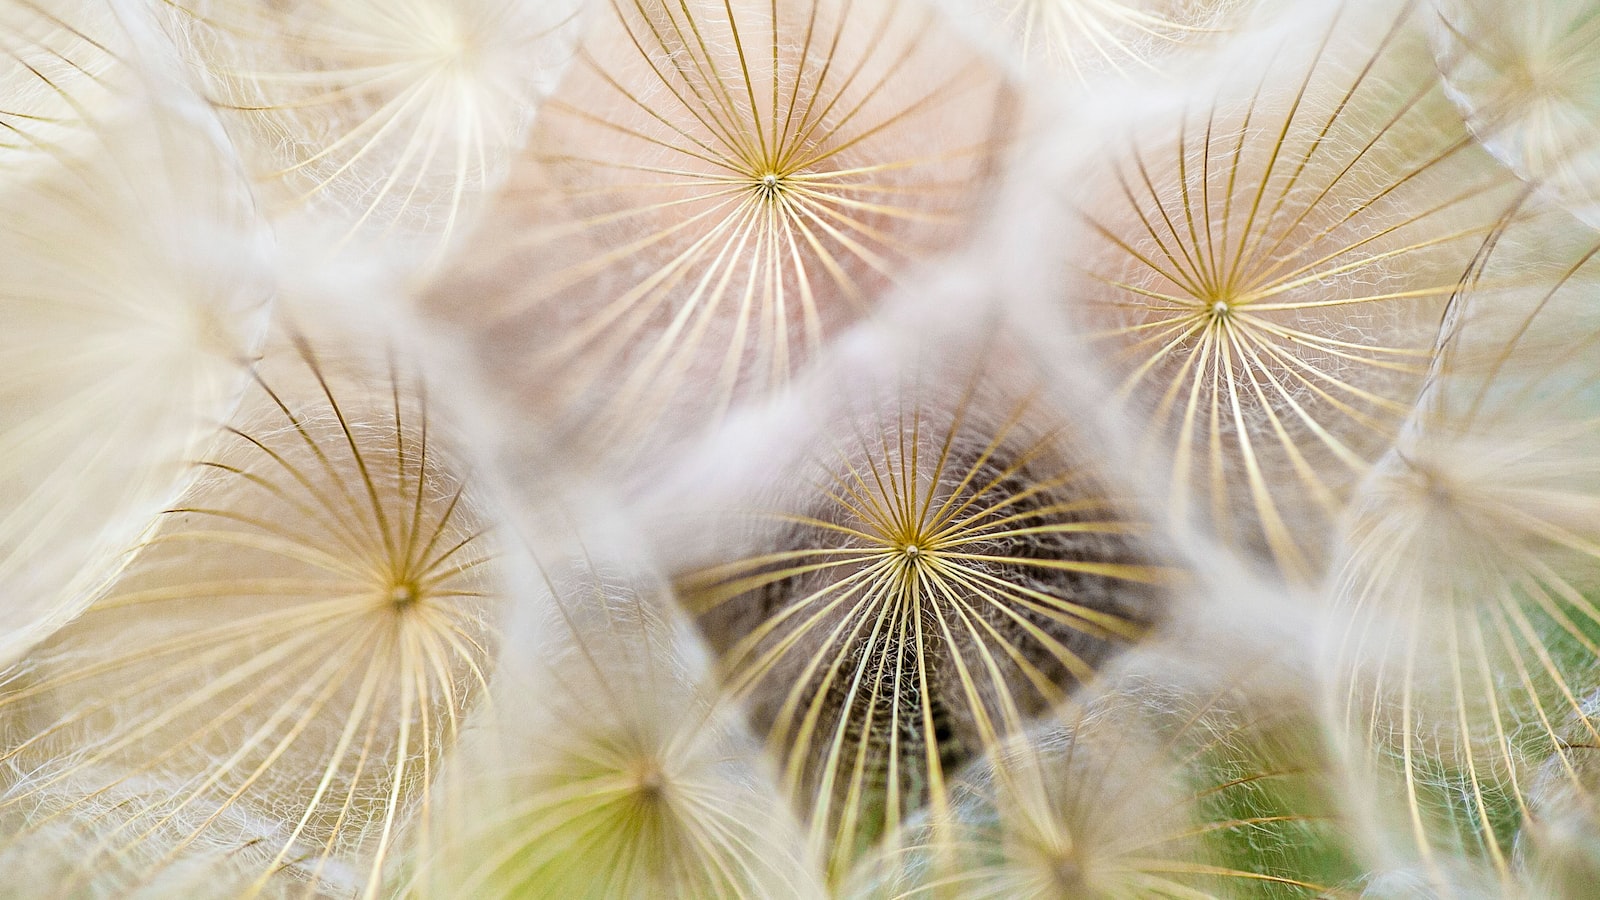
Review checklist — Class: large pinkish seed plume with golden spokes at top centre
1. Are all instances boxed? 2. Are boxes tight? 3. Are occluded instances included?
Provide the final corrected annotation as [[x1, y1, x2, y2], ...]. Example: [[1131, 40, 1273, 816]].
[[426, 0, 1010, 470]]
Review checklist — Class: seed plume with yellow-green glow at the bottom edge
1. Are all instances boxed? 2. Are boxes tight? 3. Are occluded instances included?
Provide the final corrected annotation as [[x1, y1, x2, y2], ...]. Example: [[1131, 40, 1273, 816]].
[[413, 560, 821, 900]]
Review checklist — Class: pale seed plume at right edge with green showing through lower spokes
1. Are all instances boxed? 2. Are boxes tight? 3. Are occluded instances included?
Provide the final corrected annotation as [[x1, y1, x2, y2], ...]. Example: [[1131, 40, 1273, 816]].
[[1334, 224, 1600, 881]]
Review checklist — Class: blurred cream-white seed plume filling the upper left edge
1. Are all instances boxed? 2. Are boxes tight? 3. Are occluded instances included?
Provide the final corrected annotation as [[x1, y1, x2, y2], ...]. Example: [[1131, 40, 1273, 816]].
[[0, 0, 270, 658]]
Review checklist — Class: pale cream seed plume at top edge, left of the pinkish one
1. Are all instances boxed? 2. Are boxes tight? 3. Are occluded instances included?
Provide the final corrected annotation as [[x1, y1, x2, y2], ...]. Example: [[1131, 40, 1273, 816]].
[[152, 0, 579, 261]]
